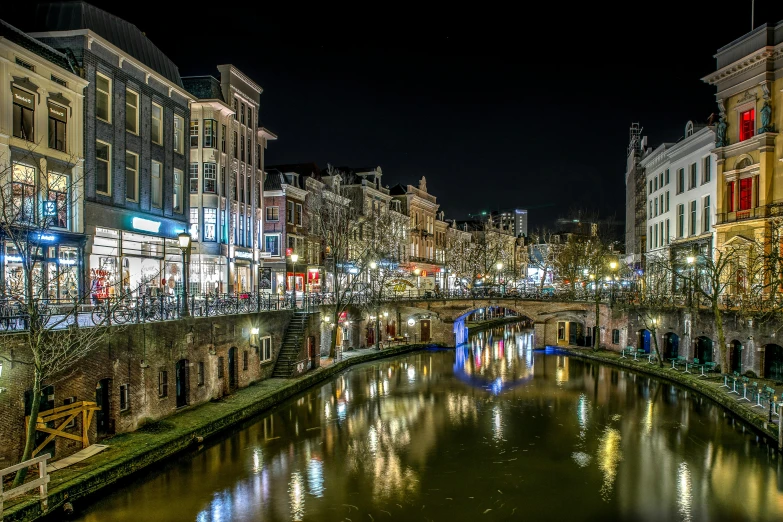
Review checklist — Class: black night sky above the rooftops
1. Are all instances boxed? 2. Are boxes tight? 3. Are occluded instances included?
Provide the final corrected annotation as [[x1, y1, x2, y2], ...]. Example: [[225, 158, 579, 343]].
[[6, 0, 783, 228]]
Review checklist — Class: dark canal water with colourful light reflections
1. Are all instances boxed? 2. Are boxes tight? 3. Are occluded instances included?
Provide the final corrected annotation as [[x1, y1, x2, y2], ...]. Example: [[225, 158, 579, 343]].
[[77, 325, 783, 522]]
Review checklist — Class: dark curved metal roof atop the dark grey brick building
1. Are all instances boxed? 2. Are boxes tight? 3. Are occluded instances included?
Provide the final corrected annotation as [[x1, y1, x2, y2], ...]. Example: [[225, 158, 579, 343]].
[[33, 2, 182, 87]]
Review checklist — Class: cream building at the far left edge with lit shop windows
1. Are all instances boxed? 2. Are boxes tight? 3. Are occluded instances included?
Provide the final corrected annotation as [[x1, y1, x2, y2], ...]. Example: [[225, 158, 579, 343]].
[[0, 21, 87, 301]]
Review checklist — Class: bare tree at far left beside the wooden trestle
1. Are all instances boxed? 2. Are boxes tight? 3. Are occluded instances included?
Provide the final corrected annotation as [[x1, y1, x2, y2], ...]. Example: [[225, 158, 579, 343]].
[[0, 143, 129, 485]]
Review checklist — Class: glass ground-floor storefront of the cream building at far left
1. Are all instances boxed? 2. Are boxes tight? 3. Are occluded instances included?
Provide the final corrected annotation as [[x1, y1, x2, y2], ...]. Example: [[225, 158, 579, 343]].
[[0, 230, 85, 301]]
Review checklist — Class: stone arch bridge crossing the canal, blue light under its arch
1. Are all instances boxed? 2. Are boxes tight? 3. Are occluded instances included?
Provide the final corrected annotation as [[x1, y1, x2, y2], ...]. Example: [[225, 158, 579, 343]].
[[388, 297, 627, 349]]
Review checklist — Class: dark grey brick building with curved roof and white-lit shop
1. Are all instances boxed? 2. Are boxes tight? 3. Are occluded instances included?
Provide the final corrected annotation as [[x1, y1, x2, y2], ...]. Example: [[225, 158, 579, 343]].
[[32, 2, 195, 299]]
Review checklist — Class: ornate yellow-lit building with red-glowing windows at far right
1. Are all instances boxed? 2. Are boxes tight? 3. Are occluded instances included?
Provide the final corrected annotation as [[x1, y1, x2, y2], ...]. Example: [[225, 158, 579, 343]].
[[703, 21, 783, 293]]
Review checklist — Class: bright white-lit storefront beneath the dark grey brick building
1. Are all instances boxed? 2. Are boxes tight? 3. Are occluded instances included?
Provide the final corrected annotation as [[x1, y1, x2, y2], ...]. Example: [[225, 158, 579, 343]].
[[87, 204, 188, 302]]
